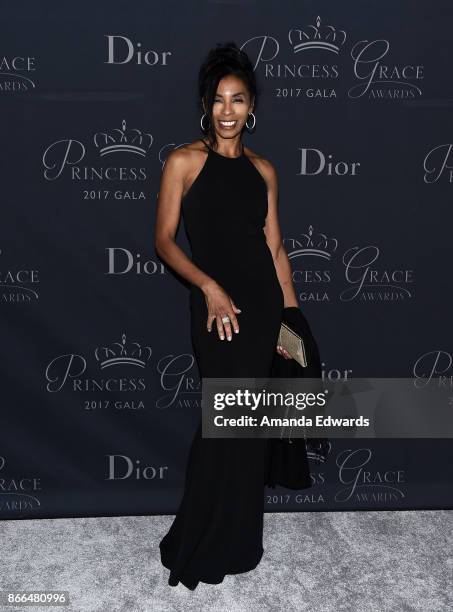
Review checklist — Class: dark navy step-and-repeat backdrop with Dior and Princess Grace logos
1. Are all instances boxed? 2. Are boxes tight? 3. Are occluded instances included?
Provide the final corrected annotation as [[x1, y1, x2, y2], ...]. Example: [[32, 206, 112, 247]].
[[0, 0, 453, 519]]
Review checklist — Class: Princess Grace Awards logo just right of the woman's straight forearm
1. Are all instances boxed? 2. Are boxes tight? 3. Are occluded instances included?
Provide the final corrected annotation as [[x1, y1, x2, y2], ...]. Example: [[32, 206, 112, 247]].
[[283, 225, 414, 302]]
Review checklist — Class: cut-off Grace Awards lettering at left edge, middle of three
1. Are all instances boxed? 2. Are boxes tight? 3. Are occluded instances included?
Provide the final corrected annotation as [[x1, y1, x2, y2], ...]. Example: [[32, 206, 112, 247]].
[[0, 249, 39, 304]]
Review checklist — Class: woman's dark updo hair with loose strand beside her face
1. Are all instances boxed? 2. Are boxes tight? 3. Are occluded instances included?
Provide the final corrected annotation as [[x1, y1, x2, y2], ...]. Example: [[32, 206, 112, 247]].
[[198, 42, 258, 146]]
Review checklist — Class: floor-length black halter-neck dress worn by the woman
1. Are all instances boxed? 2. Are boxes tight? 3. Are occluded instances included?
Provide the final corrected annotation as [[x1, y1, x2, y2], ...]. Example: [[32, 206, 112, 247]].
[[159, 143, 283, 590]]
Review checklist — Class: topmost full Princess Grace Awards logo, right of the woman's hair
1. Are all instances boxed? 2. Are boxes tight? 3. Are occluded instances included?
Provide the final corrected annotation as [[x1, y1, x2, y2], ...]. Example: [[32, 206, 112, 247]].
[[241, 15, 423, 100]]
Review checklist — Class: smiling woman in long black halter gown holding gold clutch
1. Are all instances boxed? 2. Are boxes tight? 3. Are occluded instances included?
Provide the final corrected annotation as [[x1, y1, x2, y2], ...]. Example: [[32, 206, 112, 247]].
[[155, 43, 298, 590]]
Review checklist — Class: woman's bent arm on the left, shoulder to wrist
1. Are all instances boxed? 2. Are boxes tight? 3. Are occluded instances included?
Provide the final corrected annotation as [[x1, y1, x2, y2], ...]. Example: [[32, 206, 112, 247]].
[[154, 148, 214, 291]]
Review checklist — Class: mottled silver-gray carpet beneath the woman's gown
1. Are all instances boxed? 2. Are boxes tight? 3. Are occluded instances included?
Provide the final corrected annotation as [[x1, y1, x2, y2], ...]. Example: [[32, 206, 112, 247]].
[[0, 511, 453, 612]]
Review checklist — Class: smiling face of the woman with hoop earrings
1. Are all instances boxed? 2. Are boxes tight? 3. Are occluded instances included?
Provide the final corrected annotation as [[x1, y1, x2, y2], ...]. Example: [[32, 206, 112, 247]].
[[207, 75, 253, 138]]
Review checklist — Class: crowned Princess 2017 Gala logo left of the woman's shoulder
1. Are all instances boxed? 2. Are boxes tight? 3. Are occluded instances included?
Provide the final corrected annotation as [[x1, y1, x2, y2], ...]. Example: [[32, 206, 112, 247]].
[[42, 119, 154, 201]]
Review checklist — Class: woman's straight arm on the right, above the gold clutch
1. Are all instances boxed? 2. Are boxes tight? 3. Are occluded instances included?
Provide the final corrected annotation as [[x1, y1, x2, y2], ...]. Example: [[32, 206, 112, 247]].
[[260, 159, 299, 308]]
